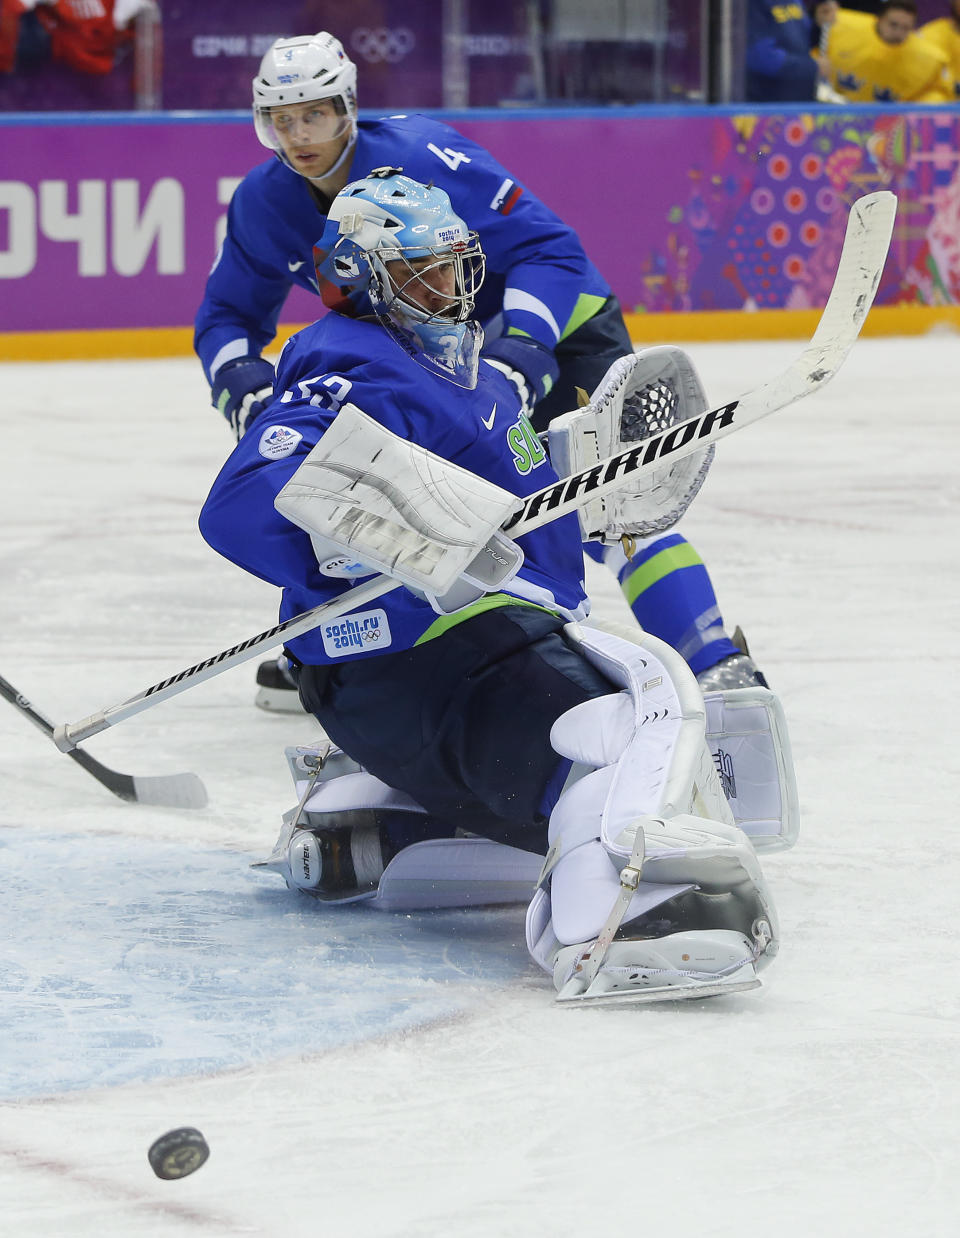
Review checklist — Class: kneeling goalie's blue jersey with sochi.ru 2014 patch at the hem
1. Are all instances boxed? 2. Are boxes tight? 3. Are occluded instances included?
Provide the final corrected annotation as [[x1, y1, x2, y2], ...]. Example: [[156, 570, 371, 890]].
[[199, 313, 587, 664]]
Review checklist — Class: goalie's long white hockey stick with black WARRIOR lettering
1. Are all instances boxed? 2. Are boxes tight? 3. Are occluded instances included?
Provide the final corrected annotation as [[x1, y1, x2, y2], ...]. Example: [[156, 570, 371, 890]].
[[53, 191, 897, 753]]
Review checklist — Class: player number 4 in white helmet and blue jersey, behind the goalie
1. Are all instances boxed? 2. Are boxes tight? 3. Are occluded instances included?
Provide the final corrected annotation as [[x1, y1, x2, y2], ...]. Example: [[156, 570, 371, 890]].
[[196, 32, 764, 711]]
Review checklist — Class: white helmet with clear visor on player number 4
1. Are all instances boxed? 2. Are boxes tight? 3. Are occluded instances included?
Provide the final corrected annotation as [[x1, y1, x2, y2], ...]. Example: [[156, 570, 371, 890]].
[[253, 30, 357, 176]]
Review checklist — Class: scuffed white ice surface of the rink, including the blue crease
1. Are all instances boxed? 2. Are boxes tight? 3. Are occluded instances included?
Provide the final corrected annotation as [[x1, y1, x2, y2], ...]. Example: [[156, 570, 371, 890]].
[[0, 335, 960, 1238]]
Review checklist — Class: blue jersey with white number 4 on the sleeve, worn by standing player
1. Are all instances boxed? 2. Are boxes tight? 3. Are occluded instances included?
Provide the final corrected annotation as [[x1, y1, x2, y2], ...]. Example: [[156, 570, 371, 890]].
[[194, 116, 611, 381]]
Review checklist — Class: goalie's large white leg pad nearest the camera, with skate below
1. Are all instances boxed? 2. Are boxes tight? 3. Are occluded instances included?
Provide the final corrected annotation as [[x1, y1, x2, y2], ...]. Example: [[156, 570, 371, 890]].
[[528, 629, 777, 997]]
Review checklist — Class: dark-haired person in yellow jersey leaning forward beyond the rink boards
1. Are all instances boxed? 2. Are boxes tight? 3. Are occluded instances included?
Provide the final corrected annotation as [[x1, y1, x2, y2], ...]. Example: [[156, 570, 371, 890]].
[[821, 0, 954, 103]]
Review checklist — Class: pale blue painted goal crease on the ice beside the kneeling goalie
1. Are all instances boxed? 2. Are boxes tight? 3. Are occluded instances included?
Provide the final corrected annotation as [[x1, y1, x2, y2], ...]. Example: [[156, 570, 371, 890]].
[[0, 828, 532, 1098]]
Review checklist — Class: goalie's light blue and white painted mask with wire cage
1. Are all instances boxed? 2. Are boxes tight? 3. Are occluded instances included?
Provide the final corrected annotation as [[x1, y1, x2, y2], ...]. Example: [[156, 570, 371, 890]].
[[321, 168, 487, 387]]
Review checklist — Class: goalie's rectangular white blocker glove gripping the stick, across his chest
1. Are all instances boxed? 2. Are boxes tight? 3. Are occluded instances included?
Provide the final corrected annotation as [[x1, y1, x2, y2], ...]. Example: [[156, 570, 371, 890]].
[[274, 404, 523, 614]]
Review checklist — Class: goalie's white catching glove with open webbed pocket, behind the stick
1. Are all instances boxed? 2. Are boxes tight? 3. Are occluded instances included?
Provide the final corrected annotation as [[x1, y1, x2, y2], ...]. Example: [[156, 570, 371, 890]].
[[549, 345, 713, 543]]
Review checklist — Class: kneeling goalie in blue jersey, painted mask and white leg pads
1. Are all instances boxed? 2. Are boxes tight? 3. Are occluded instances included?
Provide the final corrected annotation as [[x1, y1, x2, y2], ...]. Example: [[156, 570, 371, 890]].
[[201, 168, 795, 1002]]
